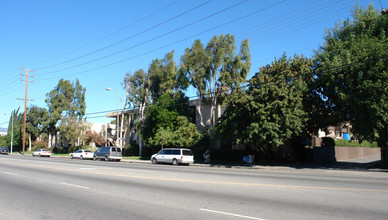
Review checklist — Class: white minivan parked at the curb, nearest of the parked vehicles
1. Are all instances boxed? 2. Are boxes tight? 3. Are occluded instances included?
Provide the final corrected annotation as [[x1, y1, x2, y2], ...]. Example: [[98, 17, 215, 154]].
[[151, 148, 194, 165]]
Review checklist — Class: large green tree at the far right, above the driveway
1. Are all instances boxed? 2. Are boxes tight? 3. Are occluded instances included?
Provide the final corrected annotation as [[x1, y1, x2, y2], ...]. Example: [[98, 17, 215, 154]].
[[315, 4, 388, 160]]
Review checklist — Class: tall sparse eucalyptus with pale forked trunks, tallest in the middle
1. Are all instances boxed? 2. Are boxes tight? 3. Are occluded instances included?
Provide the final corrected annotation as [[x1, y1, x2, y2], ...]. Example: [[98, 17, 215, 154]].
[[181, 34, 251, 132]]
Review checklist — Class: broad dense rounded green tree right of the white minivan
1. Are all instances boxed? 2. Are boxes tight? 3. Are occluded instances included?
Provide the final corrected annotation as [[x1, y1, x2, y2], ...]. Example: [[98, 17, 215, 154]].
[[215, 55, 312, 156]]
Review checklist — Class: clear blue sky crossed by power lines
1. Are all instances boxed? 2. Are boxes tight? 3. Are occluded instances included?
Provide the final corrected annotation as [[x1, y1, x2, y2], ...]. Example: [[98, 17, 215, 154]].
[[0, 0, 388, 127]]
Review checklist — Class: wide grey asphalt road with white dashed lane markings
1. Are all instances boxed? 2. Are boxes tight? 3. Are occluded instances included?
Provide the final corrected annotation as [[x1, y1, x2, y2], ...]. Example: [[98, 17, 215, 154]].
[[0, 155, 388, 219]]
